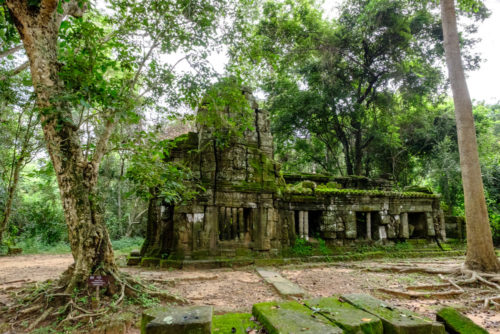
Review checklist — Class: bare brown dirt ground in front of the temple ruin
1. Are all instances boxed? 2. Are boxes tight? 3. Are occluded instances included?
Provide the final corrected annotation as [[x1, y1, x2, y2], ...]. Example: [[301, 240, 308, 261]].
[[0, 254, 500, 334]]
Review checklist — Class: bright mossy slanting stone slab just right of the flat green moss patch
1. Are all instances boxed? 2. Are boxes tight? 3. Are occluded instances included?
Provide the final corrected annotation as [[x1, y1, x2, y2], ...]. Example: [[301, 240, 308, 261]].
[[252, 301, 343, 334]]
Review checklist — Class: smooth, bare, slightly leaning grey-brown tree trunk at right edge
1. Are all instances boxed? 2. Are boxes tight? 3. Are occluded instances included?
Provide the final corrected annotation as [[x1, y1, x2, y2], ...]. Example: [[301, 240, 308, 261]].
[[441, 0, 500, 271]]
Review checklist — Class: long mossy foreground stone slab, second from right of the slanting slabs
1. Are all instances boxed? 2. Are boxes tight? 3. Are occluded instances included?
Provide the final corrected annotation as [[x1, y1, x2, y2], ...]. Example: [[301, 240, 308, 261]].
[[341, 294, 445, 334]]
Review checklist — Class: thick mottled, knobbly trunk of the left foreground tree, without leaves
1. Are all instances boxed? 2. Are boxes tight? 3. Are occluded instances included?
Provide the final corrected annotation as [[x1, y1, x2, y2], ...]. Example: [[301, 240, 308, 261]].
[[7, 0, 117, 292]]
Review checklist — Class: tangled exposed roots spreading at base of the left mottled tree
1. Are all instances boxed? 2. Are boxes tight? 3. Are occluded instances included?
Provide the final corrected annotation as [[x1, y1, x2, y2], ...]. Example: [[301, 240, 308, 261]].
[[2, 270, 186, 332]]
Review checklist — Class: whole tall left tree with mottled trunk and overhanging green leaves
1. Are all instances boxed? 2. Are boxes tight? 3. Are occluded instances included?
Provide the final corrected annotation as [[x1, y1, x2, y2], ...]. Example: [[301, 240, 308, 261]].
[[0, 0, 233, 292]]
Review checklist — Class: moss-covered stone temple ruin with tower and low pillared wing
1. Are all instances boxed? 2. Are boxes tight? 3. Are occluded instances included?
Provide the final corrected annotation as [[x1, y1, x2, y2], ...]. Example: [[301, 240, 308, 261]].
[[141, 91, 445, 259]]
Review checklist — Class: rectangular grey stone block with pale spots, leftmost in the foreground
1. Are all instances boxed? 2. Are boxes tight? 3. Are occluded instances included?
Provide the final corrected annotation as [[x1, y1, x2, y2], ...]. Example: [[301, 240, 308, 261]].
[[141, 306, 212, 334]]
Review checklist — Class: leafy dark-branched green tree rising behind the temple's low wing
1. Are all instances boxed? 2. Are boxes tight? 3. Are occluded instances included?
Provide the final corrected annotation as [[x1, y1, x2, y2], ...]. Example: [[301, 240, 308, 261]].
[[240, 0, 448, 175]]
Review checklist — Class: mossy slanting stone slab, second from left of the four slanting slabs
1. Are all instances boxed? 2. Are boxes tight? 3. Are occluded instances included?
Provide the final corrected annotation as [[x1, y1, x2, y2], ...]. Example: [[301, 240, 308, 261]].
[[305, 297, 384, 334]]
